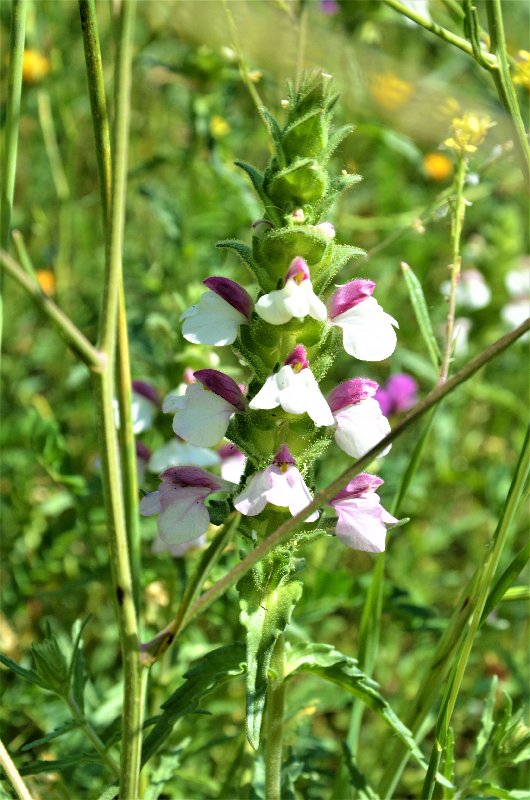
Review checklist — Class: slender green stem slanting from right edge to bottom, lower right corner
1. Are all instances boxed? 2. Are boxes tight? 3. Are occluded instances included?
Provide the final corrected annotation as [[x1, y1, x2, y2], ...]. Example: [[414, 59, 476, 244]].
[[421, 426, 530, 800]]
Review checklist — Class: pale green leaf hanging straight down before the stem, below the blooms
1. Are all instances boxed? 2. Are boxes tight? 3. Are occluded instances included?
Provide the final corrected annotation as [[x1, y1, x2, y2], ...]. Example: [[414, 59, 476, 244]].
[[237, 561, 303, 750]]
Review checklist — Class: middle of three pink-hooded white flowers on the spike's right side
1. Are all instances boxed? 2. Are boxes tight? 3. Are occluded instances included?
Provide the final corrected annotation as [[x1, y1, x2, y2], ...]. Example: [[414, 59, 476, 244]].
[[328, 378, 392, 458]]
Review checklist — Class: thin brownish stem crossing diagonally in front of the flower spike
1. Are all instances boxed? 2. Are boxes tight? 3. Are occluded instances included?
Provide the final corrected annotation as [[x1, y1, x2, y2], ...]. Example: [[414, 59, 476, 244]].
[[146, 319, 530, 652]]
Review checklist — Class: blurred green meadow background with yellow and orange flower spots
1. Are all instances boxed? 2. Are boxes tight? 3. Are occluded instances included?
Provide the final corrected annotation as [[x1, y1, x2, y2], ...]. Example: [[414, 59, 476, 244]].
[[0, 0, 530, 798]]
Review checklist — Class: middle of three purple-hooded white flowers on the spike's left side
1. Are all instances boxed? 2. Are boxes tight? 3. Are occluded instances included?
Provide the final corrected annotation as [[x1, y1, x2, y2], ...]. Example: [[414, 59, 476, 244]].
[[162, 369, 246, 447]]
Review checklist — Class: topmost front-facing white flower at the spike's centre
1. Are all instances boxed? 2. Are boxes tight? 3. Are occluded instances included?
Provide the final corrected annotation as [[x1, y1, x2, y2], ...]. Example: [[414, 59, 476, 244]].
[[256, 256, 327, 325]]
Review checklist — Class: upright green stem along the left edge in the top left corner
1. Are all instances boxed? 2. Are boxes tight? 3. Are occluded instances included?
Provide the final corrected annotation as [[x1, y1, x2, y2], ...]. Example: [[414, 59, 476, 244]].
[[0, 0, 27, 356]]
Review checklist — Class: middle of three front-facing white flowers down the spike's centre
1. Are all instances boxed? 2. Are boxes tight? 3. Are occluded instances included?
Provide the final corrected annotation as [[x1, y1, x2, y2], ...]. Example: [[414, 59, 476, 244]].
[[249, 344, 334, 427]]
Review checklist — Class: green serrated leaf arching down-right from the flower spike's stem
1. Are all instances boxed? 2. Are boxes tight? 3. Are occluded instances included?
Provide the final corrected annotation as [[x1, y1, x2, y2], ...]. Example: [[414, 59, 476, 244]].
[[287, 643, 447, 785]]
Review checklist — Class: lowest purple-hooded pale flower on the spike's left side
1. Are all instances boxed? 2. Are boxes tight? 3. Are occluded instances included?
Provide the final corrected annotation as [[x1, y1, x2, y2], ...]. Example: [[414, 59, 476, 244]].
[[140, 467, 232, 545]]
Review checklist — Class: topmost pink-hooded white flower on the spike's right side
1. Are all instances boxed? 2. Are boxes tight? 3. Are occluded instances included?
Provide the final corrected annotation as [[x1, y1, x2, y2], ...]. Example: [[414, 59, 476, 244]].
[[328, 279, 399, 361]]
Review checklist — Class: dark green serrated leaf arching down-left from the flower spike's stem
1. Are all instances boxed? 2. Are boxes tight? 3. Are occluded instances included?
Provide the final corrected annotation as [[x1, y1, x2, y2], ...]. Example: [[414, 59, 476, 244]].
[[142, 644, 245, 764]]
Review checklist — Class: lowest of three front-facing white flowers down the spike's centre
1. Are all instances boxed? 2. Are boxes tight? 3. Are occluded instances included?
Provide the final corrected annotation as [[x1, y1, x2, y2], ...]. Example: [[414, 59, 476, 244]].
[[234, 444, 318, 522]]
